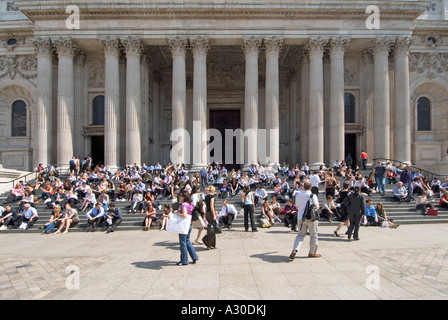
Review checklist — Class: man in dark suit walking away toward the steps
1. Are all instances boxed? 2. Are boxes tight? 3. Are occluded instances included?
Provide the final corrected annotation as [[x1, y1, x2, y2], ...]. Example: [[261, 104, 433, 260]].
[[343, 187, 366, 240]]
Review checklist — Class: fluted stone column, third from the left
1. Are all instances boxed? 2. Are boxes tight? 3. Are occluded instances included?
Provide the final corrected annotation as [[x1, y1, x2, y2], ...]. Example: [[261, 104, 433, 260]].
[[98, 37, 120, 170]]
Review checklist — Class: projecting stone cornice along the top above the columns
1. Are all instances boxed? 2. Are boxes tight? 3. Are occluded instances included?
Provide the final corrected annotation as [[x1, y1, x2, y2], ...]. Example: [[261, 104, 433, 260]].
[[16, 0, 428, 21]]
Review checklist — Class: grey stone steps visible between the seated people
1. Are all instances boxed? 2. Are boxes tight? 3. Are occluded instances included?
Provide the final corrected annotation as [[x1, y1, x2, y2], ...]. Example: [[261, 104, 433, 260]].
[[0, 174, 448, 233]]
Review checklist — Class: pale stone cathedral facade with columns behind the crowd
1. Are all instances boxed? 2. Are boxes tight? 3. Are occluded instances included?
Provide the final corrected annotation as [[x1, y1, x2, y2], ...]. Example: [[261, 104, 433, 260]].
[[0, 0, 448, 172]]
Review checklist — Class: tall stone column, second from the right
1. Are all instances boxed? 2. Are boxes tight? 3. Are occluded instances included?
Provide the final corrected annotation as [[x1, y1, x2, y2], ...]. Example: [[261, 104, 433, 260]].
[[373, 37, 391, 159]]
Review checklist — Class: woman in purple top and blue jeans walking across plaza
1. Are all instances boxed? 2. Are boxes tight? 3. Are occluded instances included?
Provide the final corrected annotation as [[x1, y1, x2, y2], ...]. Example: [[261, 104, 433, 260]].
[[174, 191, 199, 266]]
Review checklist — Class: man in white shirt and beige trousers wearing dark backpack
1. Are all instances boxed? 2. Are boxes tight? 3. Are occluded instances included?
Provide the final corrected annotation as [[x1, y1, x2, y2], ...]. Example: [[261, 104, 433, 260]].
[[289, 181, 321, 261]]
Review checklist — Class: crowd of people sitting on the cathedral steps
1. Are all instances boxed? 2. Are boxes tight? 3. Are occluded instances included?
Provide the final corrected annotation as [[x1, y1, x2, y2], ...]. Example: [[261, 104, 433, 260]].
[[0, 157, 448, 238]]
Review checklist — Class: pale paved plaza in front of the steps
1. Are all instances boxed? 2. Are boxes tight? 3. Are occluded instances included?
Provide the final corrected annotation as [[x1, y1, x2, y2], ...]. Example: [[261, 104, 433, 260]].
[[0, 224, 448, 300]]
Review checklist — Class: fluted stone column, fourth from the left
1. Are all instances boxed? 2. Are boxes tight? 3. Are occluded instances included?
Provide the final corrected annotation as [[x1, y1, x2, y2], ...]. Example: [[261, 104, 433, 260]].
[[121, 37, 142, 165]]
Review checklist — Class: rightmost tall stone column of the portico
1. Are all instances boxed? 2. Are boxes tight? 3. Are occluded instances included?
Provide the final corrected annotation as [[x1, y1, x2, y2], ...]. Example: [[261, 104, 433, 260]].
[[394, 37, 412, 163]]
